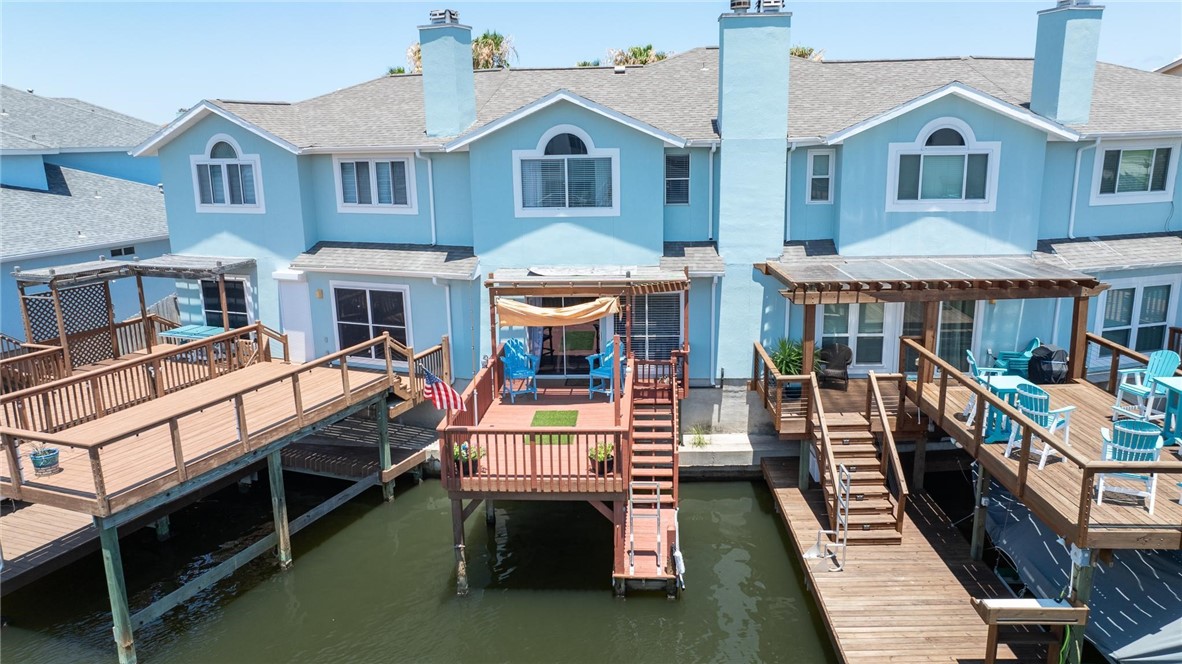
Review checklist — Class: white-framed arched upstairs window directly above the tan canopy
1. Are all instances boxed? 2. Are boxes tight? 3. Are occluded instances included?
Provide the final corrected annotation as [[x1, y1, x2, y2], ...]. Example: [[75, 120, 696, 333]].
[[513, 124, 619, 217]]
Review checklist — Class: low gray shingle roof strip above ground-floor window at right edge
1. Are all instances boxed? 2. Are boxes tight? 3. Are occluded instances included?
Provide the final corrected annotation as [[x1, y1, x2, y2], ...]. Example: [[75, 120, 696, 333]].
[[1034, 233, 1182, 274]]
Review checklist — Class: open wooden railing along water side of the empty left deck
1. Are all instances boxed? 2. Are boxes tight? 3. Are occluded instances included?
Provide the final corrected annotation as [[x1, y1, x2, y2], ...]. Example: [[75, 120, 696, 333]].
[[0, 326, 396, 516]]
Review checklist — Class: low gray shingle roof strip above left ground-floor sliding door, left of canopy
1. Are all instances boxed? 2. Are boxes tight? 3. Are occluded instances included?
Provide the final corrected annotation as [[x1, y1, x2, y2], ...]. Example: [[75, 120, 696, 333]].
[[291, 242, 480, 279]]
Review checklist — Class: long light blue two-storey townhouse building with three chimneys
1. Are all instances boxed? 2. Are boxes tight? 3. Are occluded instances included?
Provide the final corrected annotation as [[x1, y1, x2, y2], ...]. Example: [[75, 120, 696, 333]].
[[136, 2, 1182, 385]]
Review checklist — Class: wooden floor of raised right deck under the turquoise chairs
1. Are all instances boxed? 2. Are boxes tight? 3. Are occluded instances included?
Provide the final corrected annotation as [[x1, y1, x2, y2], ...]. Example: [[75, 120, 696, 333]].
[[908, 382, 1182, 549]]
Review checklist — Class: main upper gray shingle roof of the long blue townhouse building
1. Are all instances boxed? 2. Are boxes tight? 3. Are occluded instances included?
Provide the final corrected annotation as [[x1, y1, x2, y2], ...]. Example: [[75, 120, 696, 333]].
[[213, 47, 1182, 148]]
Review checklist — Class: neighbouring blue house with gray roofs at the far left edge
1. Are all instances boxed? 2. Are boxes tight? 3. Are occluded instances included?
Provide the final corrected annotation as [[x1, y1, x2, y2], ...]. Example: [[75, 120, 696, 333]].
[[0, 86, 173, 339]]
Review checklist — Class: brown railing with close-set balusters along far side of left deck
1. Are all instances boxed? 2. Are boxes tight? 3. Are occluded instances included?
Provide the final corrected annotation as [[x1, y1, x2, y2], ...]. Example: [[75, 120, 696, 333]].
[[0, 323, 288, 432]]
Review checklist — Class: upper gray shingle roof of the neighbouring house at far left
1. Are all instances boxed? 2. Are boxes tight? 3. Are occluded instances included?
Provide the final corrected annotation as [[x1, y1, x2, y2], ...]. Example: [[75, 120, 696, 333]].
[[0, 85, 160, 151]]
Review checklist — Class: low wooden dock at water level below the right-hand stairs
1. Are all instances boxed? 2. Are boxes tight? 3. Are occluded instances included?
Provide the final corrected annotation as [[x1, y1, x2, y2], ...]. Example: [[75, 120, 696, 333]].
[[762, 457, 1046, 664]]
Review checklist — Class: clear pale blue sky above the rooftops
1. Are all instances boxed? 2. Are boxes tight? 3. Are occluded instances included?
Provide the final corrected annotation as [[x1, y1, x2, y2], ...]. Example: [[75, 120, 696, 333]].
[[0, 0, 1182, 123]]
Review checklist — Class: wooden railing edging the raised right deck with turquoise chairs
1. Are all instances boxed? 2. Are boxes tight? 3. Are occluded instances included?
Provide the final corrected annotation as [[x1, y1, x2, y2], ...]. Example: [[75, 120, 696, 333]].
[[902, 334, 1182, 546]]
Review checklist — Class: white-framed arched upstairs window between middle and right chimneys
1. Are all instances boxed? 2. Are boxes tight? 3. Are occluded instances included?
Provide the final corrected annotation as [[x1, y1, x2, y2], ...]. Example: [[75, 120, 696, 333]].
[[887, 117, 1001, 211]]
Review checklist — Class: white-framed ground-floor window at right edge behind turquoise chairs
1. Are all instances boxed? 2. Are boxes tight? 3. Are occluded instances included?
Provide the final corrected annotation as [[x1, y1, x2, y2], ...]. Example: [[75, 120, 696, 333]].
[[1097, 276, 1182, 357]]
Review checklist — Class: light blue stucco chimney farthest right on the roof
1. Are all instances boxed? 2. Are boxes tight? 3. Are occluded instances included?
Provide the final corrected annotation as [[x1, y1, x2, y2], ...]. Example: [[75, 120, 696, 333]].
[[1031, 0, 1104, 124]]
